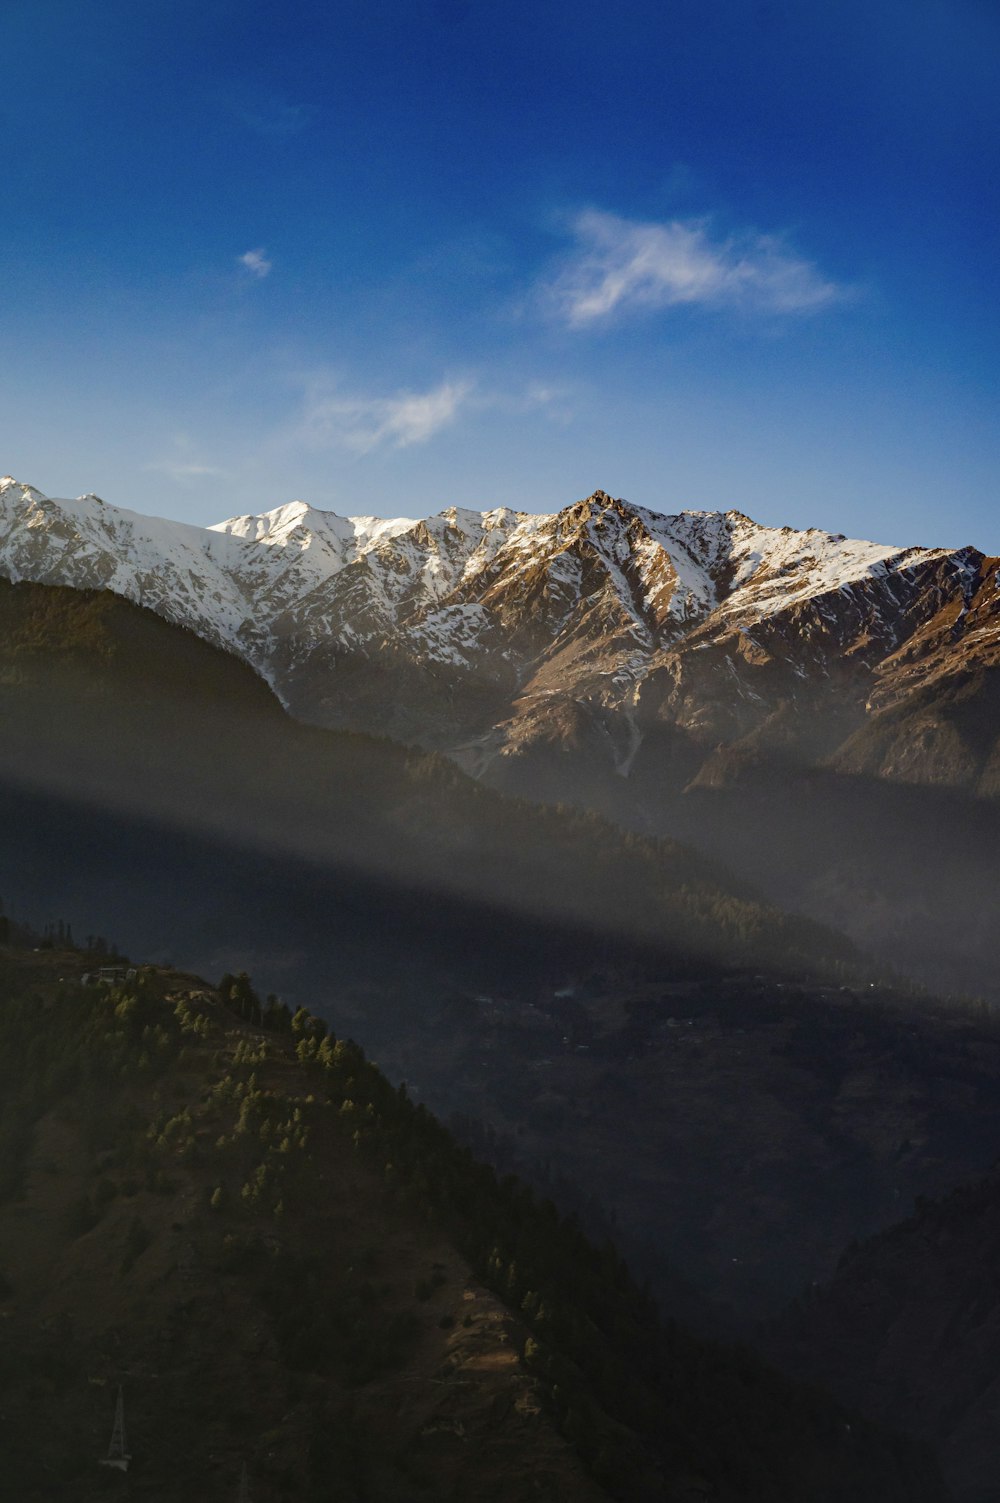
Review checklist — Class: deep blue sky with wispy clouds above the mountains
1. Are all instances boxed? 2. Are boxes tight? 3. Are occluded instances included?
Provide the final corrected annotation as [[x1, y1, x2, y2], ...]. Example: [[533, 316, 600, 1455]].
[[0, 0, 1000, 552]]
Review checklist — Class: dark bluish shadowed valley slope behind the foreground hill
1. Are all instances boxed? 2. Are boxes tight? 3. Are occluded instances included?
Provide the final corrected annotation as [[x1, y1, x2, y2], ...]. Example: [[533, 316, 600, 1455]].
[[368, 974, 1000, 1330]]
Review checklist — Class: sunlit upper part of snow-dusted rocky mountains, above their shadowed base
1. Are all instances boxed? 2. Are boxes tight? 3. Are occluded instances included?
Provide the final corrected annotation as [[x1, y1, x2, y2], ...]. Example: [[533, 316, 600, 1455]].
[[0, 476, 1000, 806]]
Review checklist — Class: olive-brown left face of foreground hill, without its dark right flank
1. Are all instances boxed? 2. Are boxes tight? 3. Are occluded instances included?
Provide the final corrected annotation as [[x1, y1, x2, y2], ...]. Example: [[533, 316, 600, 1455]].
[[0, 950, 608, 1503]]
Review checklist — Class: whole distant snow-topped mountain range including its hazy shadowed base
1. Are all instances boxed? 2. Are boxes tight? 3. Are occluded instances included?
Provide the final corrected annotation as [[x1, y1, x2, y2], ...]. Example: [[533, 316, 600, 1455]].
[[0, 478, 1000, 996]]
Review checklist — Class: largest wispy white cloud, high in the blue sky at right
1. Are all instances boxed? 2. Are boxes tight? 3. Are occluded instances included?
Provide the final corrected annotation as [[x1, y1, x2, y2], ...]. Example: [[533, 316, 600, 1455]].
[[543, 209, 845, 328]]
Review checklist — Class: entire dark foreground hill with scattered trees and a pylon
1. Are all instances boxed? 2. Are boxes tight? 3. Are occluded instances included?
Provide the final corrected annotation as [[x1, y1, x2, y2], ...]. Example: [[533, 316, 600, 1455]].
[[0, 945, 943, 1503]]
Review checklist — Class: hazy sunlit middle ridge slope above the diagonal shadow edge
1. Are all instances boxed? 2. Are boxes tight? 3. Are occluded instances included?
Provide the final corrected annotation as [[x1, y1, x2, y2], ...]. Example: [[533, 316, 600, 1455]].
[[0, 568, 850, 965]]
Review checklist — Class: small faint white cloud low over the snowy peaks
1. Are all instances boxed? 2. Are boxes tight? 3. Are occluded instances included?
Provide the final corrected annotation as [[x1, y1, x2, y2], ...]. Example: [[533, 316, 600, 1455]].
[[301, 380, 472, 454]]
